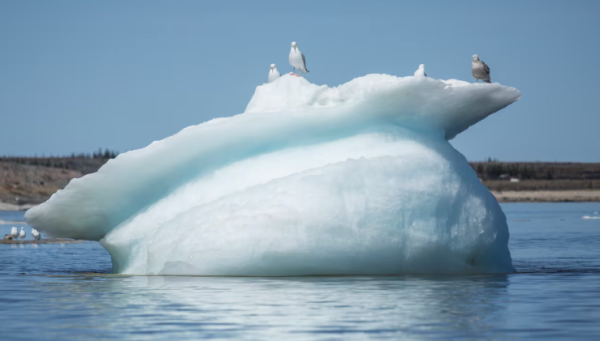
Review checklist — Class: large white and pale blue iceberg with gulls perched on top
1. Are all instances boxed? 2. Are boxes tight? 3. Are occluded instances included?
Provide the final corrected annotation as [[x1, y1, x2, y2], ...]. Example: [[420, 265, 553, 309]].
[[25, 74, 521, 276]]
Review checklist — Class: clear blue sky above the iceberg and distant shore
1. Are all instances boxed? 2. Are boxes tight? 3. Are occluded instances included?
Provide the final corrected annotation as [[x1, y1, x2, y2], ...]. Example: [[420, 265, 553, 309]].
[[0, 0, 600, 162]]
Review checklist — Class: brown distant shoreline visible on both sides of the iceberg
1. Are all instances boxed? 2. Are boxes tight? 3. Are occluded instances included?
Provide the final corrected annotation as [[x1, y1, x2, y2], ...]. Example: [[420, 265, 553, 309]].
[[0, 150, 600, 210]]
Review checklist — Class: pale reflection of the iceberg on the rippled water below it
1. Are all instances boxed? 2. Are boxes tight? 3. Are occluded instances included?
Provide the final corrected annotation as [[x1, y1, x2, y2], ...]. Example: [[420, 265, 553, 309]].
[[21, 275, 509, 339]]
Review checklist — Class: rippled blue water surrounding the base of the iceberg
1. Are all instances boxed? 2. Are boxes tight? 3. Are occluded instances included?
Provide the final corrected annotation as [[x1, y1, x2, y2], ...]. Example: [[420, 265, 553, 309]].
[[0, 203, 600, 340]]
